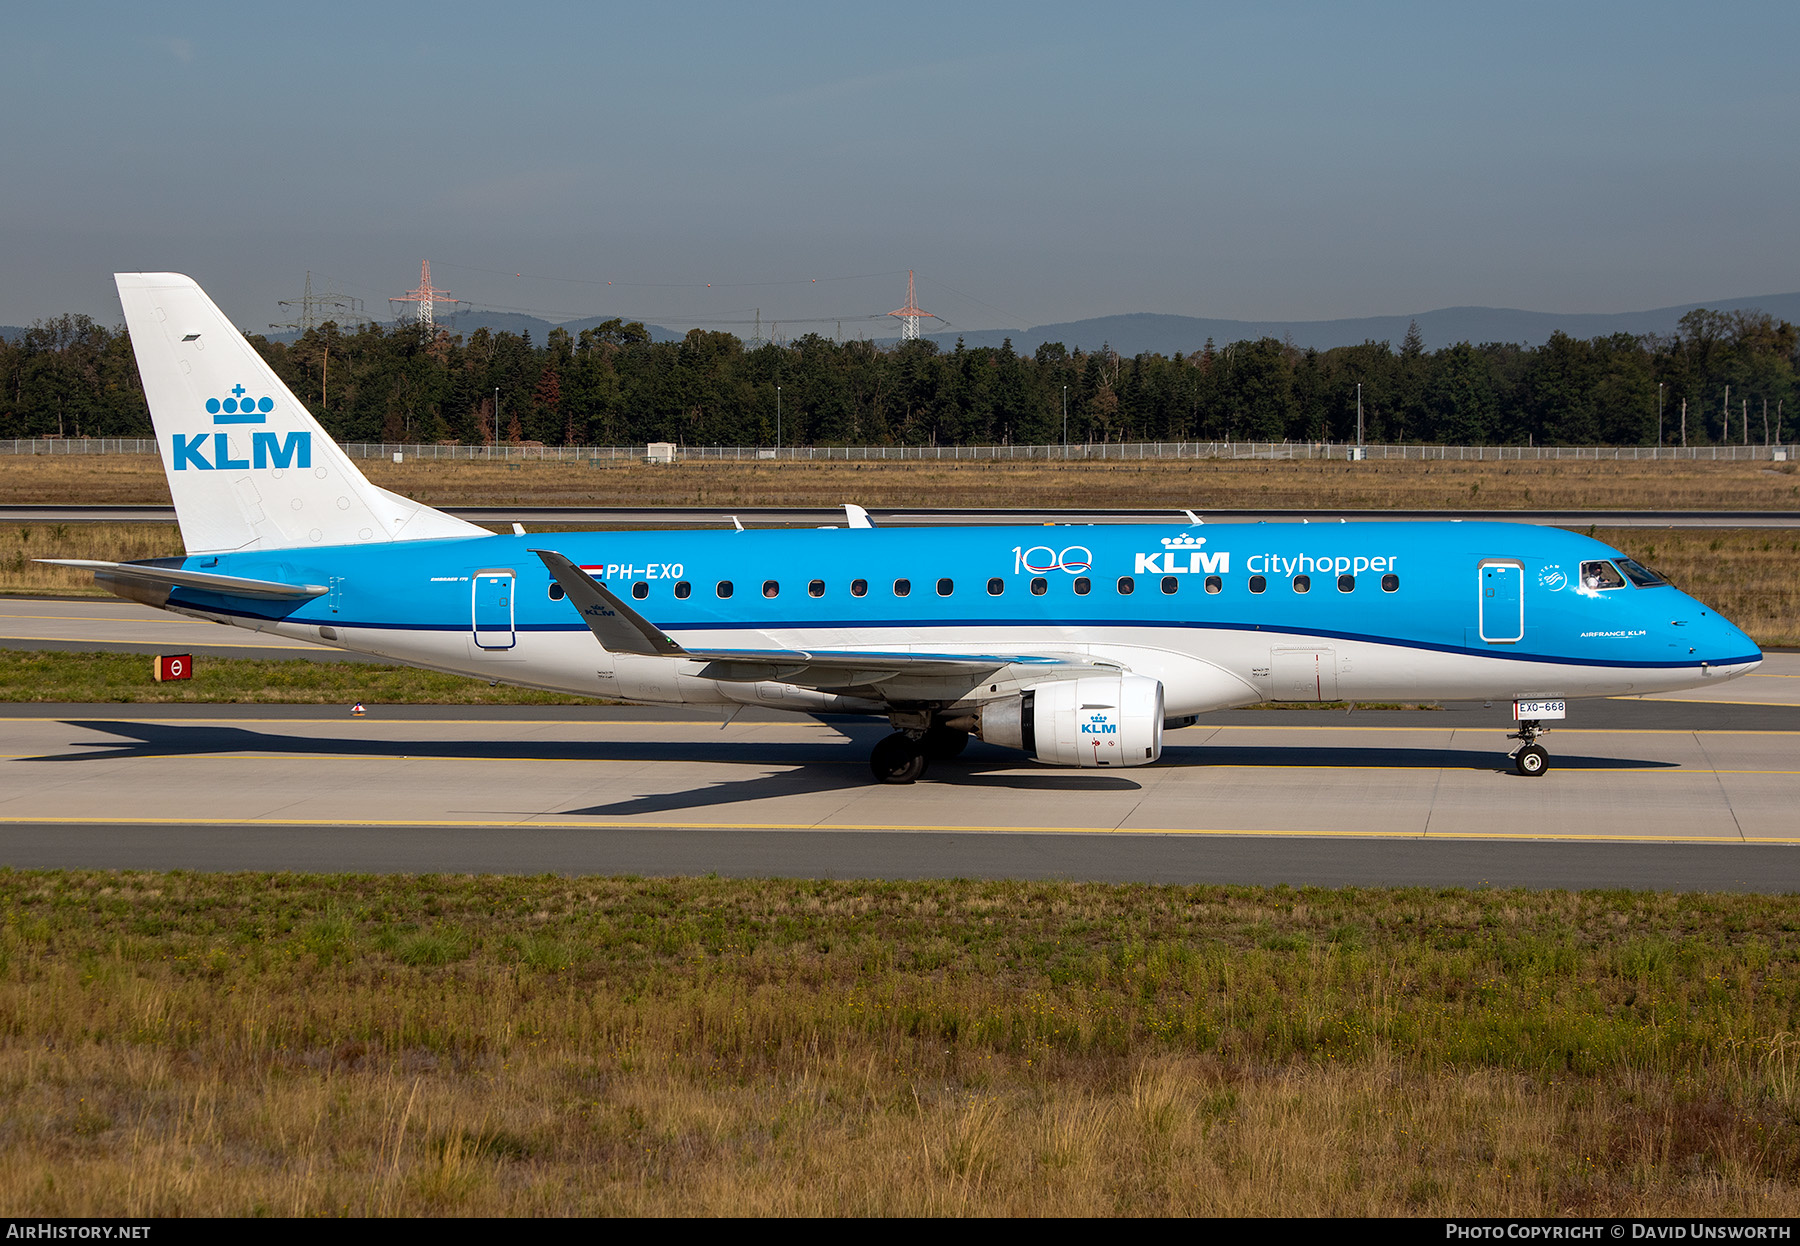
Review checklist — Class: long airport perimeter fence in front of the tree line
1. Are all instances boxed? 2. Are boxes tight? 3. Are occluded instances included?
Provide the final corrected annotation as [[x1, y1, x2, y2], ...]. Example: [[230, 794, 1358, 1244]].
[[0, 438, 1800, 466]]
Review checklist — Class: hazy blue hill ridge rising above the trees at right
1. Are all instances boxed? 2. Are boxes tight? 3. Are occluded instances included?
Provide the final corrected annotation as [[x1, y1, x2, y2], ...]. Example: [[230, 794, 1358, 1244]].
[[929, 293, 1800, 355]]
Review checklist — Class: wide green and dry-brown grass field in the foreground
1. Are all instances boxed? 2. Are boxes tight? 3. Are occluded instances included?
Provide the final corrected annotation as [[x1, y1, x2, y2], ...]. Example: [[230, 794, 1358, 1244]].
[[0, 870, 1800, 1217]]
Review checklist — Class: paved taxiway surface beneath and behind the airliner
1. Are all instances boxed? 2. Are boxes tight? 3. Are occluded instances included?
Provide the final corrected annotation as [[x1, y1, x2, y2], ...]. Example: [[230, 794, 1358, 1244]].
[[0, 600, 1800, 891]]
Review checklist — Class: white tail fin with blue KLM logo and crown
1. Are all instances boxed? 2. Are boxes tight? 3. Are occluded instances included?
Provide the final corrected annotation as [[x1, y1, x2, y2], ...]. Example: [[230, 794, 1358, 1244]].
[[113, 272, 488, 553]]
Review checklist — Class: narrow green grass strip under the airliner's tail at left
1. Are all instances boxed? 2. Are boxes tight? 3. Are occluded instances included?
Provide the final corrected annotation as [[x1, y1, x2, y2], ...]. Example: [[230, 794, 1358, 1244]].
[[0, 650, 596, 706]]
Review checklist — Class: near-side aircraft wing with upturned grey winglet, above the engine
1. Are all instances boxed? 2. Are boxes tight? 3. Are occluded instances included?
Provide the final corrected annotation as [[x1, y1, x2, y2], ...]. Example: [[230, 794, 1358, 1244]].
[[531, 549, 1111, 686]]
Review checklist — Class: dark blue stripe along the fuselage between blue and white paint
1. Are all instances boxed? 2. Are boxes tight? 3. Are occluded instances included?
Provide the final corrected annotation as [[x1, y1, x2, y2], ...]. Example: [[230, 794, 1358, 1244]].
[[178, 591, 1762, 670]]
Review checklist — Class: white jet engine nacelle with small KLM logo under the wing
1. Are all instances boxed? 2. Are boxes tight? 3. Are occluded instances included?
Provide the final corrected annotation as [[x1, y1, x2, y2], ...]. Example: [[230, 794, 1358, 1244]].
[[977, 675, 1163, 767]]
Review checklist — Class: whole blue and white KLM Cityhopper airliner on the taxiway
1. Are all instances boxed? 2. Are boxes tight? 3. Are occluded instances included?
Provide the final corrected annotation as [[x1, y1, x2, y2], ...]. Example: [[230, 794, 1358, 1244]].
[[52, 274, 1762, 781]]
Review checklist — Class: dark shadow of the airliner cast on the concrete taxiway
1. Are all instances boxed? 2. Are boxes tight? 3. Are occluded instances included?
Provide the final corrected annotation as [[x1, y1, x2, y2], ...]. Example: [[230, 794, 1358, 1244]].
[[20, 720, 1676, 817]]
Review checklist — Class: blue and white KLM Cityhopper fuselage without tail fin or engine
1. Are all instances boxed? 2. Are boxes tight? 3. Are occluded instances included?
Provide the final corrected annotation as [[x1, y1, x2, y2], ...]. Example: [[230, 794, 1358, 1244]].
[[169, 522, 1762, 713]]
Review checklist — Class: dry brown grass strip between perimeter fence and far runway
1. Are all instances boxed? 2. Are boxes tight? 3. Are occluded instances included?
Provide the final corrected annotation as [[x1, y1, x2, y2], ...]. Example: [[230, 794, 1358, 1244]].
[[0, 454, 1800, 511]]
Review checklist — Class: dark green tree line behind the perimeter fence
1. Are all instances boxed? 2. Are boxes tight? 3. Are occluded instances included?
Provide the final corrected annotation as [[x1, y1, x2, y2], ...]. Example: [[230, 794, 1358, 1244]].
[[0, 308, 1800, 447]]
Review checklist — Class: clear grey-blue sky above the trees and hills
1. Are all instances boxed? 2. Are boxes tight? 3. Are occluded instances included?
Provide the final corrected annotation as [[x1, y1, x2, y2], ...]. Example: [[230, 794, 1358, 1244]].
[[0, 2, 1800, 335]]
